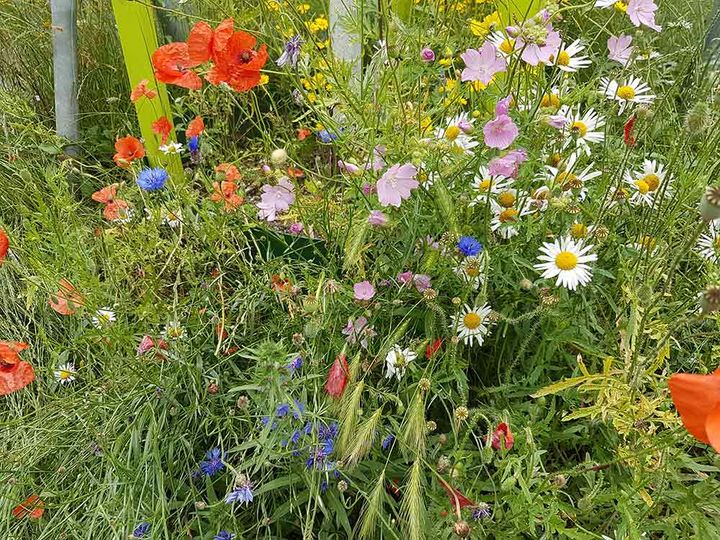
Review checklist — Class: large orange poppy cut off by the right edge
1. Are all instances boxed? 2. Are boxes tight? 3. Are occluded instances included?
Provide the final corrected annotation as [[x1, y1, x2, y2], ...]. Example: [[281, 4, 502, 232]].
[[668, 369, 720, 452]]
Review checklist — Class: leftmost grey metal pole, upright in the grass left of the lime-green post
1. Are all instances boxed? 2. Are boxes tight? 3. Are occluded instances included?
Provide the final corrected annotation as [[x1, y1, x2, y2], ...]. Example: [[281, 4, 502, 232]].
[[50, 0, 78, 148]]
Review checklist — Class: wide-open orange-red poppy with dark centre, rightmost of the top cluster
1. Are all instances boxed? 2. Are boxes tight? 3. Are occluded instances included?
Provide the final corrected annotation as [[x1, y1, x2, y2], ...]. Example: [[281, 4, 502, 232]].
[[206, 32, 268, 92]]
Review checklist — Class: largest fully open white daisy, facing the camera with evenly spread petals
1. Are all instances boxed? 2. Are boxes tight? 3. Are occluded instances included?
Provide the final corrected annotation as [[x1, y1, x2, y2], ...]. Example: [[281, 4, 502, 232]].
[[534, 236, 597, 291]]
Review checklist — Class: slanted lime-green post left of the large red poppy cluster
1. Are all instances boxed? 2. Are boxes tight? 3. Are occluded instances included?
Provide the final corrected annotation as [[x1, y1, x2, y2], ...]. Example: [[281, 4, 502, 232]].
[[112, 0, 184, 180]]
